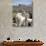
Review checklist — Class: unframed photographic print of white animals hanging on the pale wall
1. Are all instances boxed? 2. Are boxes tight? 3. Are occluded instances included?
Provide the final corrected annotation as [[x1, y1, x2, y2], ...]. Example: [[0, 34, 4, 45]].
[[12, 0, 33, 27]]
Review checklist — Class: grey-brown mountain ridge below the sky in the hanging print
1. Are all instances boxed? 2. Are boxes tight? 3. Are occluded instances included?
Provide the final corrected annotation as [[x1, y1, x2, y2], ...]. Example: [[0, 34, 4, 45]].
[[13, 4, 32, 12]]
